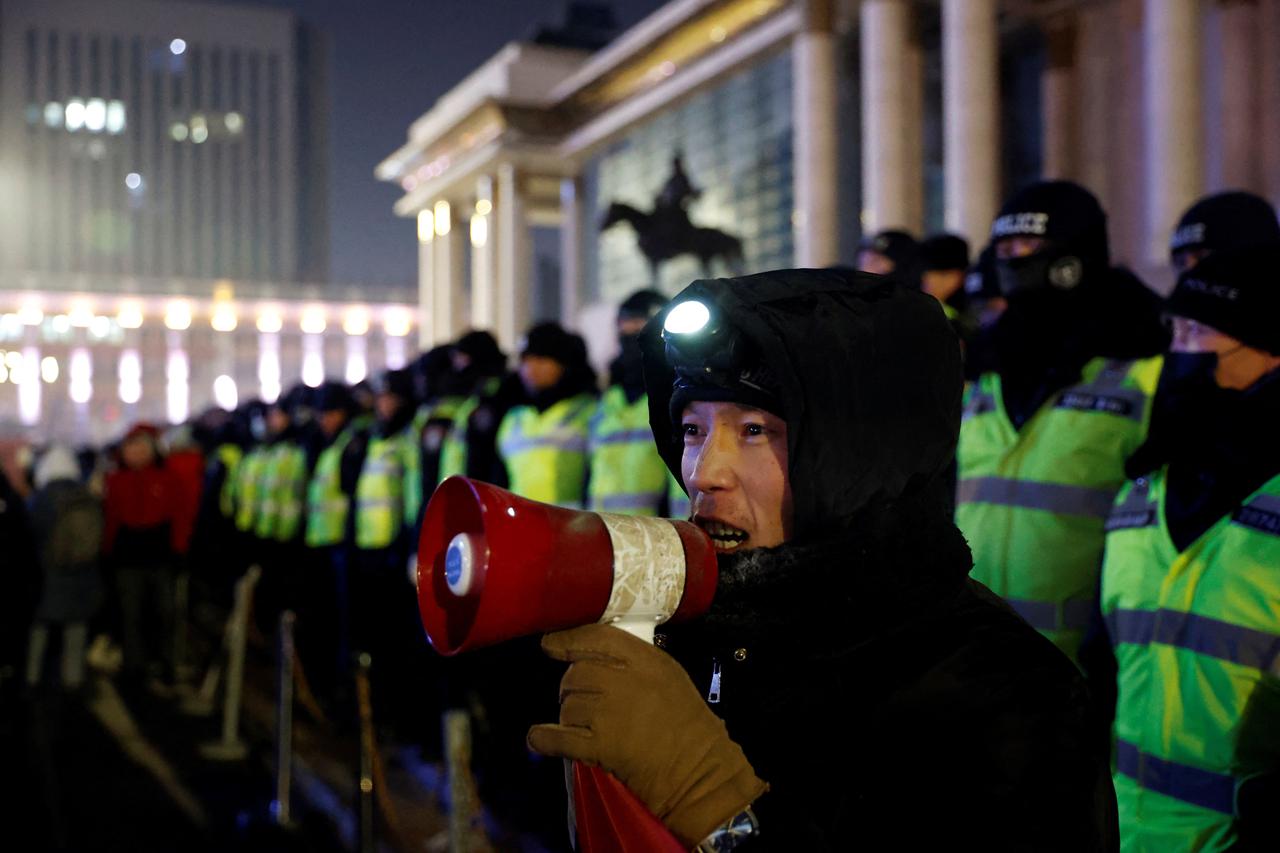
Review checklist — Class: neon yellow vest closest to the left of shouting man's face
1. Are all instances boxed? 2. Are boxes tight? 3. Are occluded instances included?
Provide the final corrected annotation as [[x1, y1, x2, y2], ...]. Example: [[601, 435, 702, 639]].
[[586, 386, 671, 516]]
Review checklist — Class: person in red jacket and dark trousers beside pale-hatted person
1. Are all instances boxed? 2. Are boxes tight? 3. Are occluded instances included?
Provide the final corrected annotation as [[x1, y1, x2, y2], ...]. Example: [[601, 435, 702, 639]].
[[102, 424, 189, 679]]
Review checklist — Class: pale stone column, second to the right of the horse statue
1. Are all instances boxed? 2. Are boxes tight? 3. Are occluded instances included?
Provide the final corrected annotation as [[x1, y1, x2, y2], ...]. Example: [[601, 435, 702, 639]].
[[860, 0, 920, 233]]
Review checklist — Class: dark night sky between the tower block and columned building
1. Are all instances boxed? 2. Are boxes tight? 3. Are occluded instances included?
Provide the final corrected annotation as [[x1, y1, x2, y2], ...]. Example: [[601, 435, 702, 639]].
[[204, 0, 663, 284]]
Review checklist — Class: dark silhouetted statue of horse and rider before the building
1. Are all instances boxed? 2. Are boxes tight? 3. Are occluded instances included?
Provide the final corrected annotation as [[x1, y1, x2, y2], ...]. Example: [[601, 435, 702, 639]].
[[600, 152, 742, 284]]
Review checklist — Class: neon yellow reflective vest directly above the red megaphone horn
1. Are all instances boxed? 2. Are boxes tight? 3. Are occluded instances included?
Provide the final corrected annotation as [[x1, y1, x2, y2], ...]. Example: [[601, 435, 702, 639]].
[[498, 394, 595, 510]]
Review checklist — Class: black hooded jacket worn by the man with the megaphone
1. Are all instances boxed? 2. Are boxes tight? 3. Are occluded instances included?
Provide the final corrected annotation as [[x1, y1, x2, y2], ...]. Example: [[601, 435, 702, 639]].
[[645, 270, 1117, 852]]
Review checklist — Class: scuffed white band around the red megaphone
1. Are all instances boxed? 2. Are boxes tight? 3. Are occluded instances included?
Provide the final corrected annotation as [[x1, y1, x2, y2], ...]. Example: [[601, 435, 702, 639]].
[[599, 512, 685, 643]]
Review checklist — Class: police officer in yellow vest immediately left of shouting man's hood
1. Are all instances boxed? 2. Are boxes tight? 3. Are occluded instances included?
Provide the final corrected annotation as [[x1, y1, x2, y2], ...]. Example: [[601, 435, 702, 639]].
[[588, 291, 671, 515]]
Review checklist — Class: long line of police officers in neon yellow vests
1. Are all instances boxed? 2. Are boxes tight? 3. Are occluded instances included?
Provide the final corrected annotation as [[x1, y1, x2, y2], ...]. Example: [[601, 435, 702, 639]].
[[194, 182, 1280, 850]]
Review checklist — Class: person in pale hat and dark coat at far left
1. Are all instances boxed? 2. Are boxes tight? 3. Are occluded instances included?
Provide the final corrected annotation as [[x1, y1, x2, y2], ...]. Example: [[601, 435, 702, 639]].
[[27, 444, 102, 690]]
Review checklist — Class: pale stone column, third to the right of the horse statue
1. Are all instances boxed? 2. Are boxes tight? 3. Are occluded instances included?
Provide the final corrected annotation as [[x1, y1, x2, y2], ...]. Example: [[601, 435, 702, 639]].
[[942, 0, 1000, 248]]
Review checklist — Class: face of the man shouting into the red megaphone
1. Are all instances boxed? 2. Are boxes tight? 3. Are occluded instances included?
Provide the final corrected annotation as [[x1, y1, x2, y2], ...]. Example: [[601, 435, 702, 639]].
[[681, 402, 792, 553]]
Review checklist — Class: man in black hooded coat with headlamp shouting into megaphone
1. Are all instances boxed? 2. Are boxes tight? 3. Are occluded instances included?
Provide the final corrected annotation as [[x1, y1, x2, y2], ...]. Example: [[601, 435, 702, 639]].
[[529, 270, 1116, 853]]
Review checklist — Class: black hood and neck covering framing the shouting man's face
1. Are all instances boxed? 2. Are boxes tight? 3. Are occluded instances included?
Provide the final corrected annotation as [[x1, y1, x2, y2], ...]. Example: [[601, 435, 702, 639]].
[[643, 269, 972, 643]]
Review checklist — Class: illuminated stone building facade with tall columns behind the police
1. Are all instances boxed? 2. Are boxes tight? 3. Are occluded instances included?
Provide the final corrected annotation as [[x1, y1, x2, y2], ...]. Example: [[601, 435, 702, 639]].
[[376, 0, 1280, 360]]
